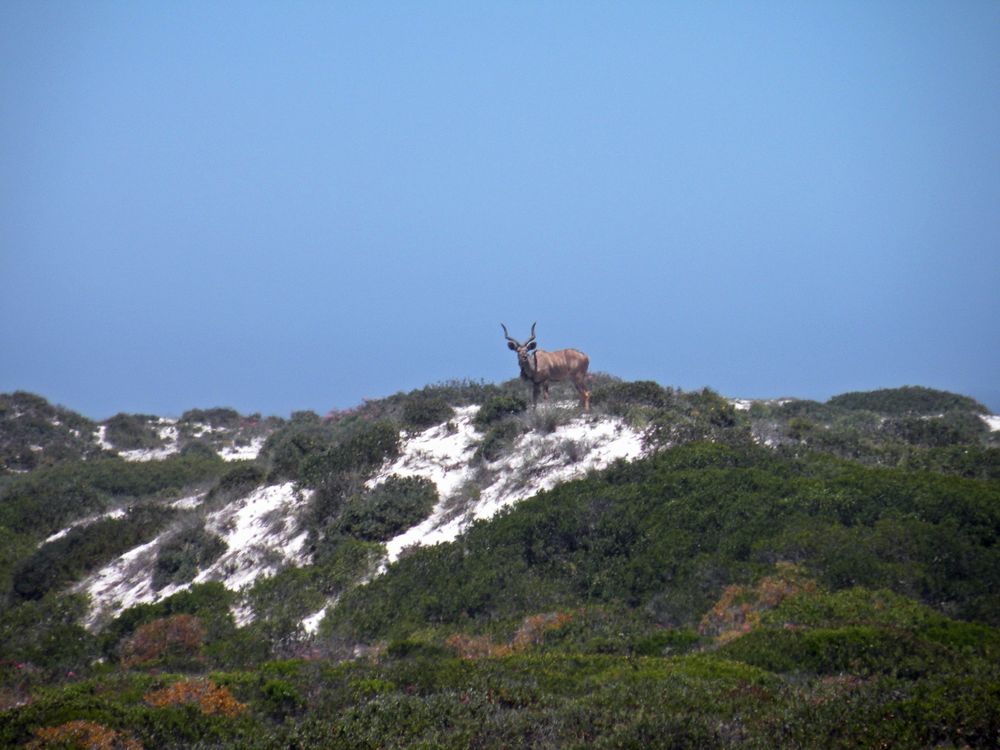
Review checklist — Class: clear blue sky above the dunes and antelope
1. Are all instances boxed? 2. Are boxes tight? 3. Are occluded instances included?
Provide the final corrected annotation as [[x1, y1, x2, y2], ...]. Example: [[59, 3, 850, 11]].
[[0, 0, 1000, 418]]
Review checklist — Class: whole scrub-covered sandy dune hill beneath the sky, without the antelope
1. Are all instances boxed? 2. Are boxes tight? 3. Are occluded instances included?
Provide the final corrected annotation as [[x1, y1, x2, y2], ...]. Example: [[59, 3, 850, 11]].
[[0, 384, 1000, 747]]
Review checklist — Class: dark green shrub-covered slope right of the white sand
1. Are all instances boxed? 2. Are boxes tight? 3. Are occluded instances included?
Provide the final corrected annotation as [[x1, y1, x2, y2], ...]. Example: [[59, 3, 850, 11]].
[[326, 444, 1000, 639]]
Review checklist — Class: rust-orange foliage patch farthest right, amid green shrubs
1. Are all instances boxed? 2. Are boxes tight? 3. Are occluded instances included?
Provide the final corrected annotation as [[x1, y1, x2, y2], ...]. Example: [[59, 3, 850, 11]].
[[698, 563, 818, 642]]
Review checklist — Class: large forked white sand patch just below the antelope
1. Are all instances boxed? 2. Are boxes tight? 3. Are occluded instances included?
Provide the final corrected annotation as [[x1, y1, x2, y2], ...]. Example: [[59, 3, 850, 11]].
[[373, 406, 643, 571]]
